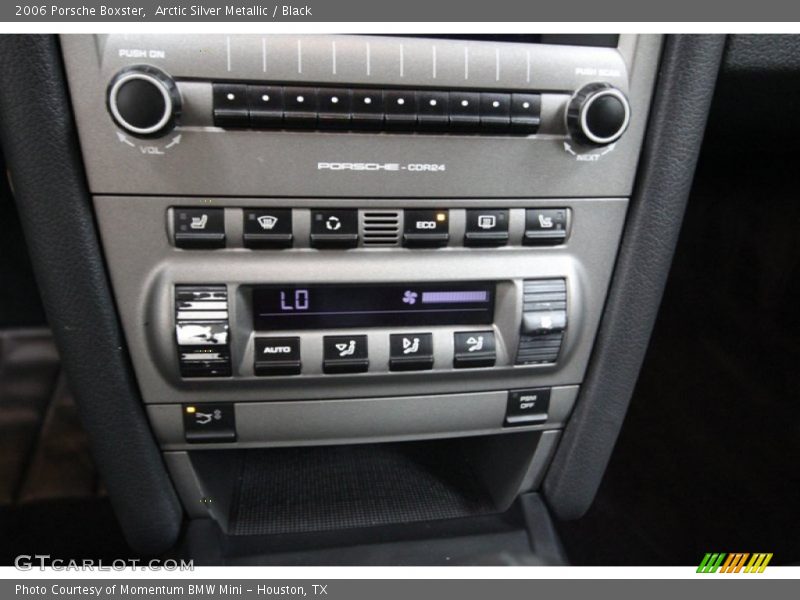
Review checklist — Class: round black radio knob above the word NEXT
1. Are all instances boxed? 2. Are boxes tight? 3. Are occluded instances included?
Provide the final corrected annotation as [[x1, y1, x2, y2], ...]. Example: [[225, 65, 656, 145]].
[[567, 83, 631, 146]]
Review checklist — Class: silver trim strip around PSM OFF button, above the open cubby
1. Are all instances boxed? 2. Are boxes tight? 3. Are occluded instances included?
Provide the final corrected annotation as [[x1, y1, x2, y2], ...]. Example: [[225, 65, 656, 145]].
[[147, 386, 578, 450]]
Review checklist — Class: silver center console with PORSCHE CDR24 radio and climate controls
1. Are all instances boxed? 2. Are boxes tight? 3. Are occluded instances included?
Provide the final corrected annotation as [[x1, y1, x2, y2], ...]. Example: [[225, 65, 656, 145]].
[[54, 35, 661, 544]]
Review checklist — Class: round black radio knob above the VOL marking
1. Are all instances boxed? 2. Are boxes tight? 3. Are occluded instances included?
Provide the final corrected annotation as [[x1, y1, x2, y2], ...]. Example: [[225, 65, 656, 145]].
[[108, 65, 181, 137]]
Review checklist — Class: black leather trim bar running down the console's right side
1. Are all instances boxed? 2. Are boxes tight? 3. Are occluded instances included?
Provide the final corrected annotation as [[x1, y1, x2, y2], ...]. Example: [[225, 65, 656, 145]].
[[544, 35, 725, 519]]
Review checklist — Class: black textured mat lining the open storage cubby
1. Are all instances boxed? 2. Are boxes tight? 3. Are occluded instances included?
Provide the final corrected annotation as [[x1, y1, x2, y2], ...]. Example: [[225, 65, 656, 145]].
[[229, 442, 496, 535]]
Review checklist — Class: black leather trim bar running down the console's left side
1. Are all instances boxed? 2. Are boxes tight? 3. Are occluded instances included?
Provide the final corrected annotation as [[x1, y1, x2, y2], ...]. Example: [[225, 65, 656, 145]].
[[0, 35, 182, 554]]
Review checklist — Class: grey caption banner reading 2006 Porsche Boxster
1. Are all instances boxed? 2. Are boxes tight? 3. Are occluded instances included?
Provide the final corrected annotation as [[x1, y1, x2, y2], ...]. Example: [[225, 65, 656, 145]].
[[0, 0, 800, 23]]
